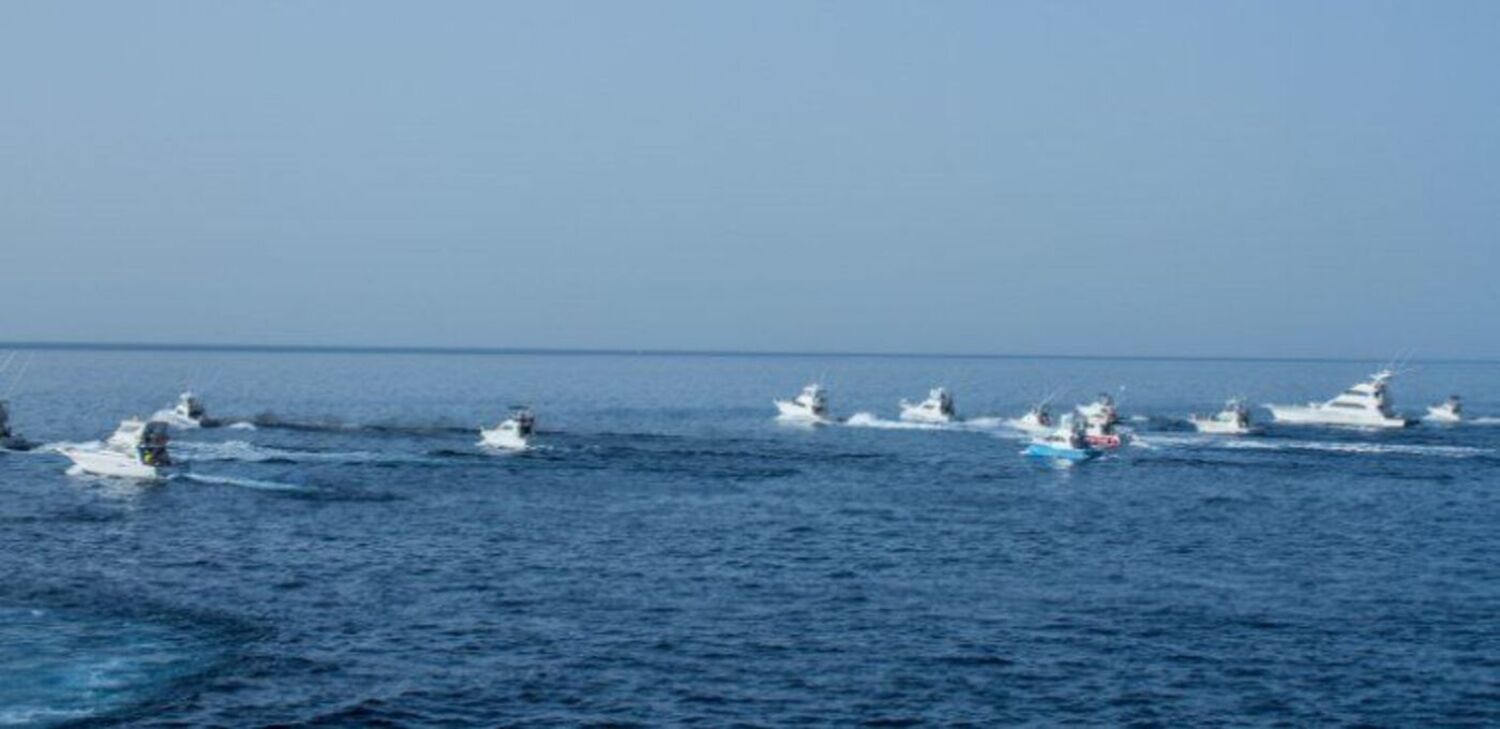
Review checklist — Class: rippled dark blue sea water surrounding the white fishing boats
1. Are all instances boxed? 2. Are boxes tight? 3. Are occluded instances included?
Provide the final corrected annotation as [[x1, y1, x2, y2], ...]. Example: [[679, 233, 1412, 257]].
[[0, 353, 1500, 726]]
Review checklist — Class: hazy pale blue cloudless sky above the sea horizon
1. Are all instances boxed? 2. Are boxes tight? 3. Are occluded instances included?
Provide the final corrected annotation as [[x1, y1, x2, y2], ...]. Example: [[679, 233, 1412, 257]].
[[0, 0, 1500, 359]]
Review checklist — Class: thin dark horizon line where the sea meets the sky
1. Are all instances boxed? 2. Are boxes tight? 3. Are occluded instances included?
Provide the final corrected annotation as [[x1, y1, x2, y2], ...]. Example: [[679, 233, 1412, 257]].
[[0, 341, 1500, 365]]
